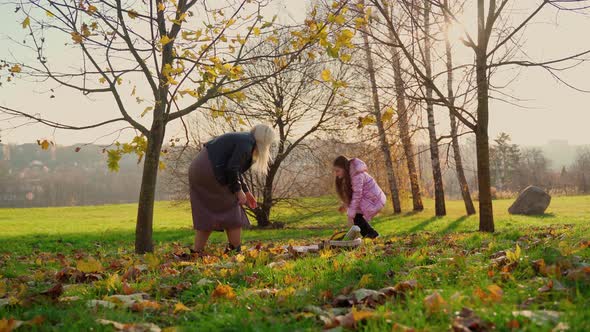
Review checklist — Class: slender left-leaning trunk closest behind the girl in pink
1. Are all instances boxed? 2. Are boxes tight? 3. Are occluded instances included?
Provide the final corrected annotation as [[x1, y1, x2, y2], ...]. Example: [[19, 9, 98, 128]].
[[363, 22, 402, 213]]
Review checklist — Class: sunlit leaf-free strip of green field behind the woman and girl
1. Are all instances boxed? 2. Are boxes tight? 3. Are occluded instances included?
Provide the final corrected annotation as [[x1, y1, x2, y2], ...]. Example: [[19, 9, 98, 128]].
[[0, 196, 590, 253]]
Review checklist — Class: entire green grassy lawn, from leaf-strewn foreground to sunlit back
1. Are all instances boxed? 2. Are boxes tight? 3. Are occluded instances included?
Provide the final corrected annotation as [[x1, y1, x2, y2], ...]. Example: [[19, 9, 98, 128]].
[[0, 196, 590, 331]]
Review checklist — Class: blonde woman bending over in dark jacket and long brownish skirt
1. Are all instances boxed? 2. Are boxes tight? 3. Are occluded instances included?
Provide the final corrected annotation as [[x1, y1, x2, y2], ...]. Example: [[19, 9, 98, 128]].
[[189, 124, 275, 253]]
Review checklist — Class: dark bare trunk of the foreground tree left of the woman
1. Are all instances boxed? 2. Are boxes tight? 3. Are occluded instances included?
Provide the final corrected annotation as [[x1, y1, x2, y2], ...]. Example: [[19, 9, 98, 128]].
[[135, 123, 165, 254]]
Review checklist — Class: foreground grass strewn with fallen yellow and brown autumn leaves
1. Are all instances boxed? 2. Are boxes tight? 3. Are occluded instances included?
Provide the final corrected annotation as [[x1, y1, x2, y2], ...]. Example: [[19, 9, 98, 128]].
[[0, 227, 590, 331]]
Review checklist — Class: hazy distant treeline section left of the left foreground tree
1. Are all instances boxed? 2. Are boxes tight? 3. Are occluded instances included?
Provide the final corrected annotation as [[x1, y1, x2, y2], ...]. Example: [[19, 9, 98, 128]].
[[0, 144, 168, 207]]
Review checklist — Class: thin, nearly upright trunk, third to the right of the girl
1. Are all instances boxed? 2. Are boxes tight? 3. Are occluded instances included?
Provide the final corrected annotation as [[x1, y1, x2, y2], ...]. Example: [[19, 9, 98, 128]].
[[424, 0, 447, 216]]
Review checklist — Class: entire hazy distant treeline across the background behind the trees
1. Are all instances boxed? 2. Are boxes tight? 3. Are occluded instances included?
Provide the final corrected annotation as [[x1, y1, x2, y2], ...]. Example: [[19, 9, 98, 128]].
[[0, 134, 590, 207]]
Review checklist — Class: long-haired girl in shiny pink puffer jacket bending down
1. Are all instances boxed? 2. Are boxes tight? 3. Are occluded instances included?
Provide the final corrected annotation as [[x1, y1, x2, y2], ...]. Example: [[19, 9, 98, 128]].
[[334, 156, 386, 239]]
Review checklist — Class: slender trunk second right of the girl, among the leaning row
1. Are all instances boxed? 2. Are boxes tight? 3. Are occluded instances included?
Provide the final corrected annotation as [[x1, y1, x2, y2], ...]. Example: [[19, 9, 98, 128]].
[[390, 45, 424, 211]]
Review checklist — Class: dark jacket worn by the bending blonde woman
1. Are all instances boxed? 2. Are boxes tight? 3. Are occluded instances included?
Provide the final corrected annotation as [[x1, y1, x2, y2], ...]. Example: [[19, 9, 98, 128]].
[[205, 132, 256, 193]]
